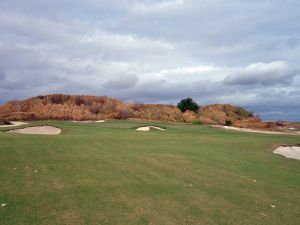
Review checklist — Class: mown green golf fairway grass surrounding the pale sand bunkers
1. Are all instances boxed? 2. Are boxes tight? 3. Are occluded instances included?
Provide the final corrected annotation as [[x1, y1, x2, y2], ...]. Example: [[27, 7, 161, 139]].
[[0, 121, 300, 225]]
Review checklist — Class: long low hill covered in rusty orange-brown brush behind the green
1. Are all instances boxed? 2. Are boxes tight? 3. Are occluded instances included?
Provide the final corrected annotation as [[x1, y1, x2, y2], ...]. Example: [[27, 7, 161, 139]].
[[0, 94, 260, 125]]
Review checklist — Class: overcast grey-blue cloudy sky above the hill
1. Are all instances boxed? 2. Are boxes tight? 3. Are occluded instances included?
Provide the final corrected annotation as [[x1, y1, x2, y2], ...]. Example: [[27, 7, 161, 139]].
[[0, 0, 300, 121]]
